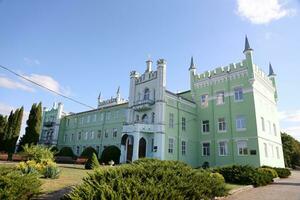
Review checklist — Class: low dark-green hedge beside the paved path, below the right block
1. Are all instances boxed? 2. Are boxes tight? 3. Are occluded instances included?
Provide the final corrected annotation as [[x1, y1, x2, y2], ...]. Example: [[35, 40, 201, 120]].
[[213, 165, 274, 187]]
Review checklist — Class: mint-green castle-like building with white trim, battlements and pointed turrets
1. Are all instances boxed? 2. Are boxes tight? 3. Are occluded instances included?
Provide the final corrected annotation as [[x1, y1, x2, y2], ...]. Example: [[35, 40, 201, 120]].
[[39, 38, 284, 167]]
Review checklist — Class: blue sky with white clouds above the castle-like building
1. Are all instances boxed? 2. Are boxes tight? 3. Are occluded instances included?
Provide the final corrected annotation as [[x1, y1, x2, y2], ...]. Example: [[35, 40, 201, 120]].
[[0, 0, 300, 139]]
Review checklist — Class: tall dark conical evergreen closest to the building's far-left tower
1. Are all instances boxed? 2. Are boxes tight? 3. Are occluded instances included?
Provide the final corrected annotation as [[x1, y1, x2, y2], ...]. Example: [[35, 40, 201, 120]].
[[19, 103, 42, 151]]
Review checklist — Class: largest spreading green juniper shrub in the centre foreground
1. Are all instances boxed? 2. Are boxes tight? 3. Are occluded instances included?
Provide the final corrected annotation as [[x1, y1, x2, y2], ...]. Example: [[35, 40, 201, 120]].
[[65, 159, 227, 200]]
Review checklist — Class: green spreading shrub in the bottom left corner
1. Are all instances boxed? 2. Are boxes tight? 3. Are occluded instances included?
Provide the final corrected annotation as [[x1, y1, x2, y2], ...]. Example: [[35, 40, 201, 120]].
[[0, 167, 41, 200]]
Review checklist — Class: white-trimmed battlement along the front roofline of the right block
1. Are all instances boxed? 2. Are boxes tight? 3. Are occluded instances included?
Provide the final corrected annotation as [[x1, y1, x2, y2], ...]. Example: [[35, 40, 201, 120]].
[[194, 60, 246, 81]]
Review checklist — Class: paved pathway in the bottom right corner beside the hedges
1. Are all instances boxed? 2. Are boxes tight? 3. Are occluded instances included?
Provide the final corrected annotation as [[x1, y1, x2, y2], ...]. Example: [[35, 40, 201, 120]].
[[225, 171, 300, 200]]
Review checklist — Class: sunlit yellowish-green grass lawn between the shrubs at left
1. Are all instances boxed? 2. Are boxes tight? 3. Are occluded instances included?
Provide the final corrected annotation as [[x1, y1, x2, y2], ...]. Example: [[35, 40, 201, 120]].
[[0, 162, 93, 194]]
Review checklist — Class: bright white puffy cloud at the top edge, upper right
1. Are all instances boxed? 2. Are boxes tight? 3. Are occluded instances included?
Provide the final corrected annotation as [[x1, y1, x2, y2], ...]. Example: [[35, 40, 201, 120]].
[[237, 0, 296, 24]]
